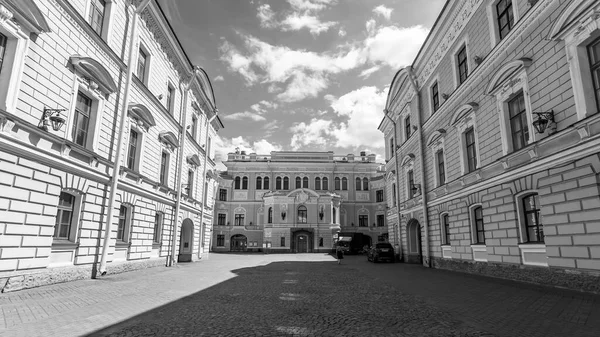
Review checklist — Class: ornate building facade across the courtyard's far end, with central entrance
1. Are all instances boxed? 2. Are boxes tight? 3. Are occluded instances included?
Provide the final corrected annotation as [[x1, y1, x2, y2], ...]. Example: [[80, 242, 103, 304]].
[[211, 151, 387, 253]]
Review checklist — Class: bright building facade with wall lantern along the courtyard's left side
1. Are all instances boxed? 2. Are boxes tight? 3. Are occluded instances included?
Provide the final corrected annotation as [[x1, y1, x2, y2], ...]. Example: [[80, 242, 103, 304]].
[[0, 0, 223, 291]]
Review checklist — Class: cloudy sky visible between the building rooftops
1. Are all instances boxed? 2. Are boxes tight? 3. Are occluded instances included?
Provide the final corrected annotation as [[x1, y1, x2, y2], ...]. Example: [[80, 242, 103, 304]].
[[159, 0, 446, 166]]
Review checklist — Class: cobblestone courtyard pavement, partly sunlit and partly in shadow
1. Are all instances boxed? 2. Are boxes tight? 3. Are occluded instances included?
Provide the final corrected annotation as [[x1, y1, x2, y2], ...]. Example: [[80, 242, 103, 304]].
[[0, 254, 600, 337]]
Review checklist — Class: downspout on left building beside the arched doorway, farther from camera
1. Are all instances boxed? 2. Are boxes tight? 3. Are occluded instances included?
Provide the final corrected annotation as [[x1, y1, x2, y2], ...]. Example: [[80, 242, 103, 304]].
[[168, 69, 196, 267]]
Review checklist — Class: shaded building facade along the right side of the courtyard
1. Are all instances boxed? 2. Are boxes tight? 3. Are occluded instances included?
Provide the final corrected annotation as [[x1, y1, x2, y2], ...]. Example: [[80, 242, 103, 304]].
[[380, 0, 600, 292]]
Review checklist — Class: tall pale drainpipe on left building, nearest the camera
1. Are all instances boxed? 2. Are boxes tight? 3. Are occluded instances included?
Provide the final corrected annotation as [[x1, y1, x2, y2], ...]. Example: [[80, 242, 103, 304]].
[[100, 0, 150, 276]]
